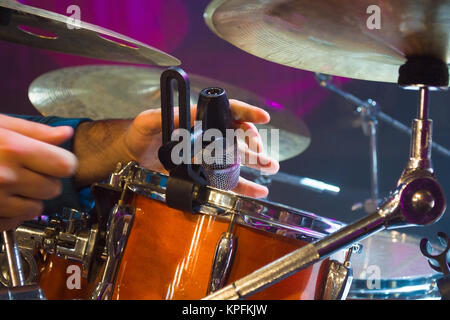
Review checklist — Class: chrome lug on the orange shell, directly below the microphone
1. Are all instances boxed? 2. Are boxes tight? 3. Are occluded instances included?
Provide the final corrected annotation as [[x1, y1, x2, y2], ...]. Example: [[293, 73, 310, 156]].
[[207, 214, 237, 295]]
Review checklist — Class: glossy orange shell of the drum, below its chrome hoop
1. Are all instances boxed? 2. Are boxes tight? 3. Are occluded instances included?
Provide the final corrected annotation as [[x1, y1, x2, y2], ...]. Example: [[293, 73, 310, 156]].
[[114, 196, 322, 300]]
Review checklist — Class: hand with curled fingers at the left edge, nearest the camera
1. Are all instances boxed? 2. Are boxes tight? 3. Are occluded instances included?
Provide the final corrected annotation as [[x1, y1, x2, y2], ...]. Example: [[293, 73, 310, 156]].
[[0, 115, 77, 231]]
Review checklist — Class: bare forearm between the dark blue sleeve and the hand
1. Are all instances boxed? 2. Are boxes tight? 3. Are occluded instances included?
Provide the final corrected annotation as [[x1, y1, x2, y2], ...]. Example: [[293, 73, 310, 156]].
[[73, 120, 133, 187]]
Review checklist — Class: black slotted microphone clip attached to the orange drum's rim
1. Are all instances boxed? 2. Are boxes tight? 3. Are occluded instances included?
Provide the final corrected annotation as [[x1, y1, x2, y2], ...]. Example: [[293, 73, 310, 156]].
[[158, 67, 207, 212]]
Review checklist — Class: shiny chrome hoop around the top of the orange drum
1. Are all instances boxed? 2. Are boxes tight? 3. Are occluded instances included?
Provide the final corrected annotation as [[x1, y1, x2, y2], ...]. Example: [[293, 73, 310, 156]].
[[128, 167, 345, 242]]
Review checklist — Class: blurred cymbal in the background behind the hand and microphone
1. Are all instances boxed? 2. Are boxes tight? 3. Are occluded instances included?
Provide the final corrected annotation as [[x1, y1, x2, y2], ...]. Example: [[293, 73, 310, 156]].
[[28, 65, 311, 161]]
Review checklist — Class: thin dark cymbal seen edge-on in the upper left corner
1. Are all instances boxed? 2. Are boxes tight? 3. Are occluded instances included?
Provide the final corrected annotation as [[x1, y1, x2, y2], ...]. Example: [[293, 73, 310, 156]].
[[0, 0, 180, 66]]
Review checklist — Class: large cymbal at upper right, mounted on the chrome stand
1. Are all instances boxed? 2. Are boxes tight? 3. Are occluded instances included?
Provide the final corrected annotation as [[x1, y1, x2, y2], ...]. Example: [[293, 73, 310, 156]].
[[204, 0, 450, 82]]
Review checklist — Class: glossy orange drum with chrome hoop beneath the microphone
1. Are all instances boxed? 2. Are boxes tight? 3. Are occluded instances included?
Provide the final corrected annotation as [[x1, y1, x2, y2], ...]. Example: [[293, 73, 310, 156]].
[[103, 169, 342, 300]]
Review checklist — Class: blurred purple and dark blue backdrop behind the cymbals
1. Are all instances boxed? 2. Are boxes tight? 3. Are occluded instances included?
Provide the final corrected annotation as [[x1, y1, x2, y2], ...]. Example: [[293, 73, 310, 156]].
[[0, 0, 450, 238]]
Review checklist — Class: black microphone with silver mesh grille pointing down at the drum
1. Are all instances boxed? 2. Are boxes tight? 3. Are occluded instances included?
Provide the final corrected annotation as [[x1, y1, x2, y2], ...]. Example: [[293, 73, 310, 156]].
[[195, 87, 241, 190]]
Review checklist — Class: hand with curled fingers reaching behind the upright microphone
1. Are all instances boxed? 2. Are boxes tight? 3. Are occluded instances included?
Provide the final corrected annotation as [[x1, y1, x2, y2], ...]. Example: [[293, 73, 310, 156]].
[[122, 100, 280, 198]]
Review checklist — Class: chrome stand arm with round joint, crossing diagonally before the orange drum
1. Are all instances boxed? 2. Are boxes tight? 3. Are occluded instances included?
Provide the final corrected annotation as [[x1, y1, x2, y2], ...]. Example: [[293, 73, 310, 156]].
[[204, 87, 446, 300]]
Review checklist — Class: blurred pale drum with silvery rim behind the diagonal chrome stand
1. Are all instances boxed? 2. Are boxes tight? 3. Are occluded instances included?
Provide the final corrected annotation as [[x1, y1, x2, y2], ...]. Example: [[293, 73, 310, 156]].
[[348, 231, 442, 300]]
